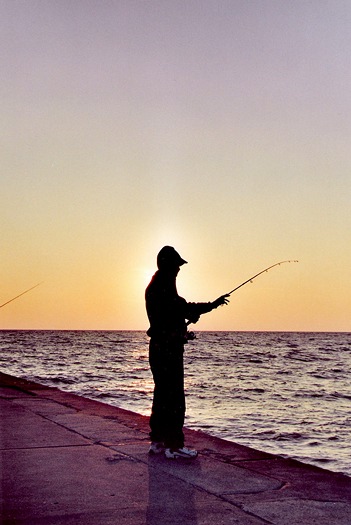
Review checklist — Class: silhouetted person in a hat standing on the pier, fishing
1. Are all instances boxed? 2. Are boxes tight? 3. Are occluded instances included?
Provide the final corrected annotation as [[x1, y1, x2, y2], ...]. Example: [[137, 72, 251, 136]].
[[145, 246, 228, 458]]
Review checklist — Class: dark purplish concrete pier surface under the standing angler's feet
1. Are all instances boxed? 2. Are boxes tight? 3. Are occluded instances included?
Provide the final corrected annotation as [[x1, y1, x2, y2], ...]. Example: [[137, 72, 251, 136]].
[[0, 374, 351, 525]]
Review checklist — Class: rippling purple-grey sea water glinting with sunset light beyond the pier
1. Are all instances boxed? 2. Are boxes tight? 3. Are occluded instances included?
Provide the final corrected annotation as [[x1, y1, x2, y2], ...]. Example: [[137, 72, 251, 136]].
[[0, 330, 351, 475]]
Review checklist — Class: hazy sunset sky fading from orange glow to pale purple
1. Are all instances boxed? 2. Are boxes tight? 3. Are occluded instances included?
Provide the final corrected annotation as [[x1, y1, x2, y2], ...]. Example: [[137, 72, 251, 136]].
[[0, 0, 351, 332]]
